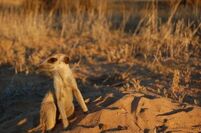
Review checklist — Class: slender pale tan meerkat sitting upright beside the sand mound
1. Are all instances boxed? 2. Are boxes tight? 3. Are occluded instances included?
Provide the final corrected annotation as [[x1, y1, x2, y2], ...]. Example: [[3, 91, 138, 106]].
[[30, 54, 88, 131]]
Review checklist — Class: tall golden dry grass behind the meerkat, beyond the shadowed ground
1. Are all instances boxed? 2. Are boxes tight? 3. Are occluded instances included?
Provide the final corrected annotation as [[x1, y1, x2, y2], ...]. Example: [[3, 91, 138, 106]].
[[0, 0, 201, 101]]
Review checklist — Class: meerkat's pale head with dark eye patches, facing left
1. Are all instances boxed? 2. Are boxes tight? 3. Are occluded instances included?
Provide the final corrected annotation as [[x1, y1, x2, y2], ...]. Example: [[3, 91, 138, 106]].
[[38, 54, 69, 74]]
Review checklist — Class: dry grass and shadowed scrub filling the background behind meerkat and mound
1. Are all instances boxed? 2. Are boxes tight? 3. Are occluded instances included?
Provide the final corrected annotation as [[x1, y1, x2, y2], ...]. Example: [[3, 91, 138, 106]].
[[0, 0, 201, 132]]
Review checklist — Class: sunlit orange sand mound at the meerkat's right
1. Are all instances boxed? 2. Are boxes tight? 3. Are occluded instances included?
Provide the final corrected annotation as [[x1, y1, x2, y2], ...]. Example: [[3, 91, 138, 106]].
[[0, 93, 201, 133]]
